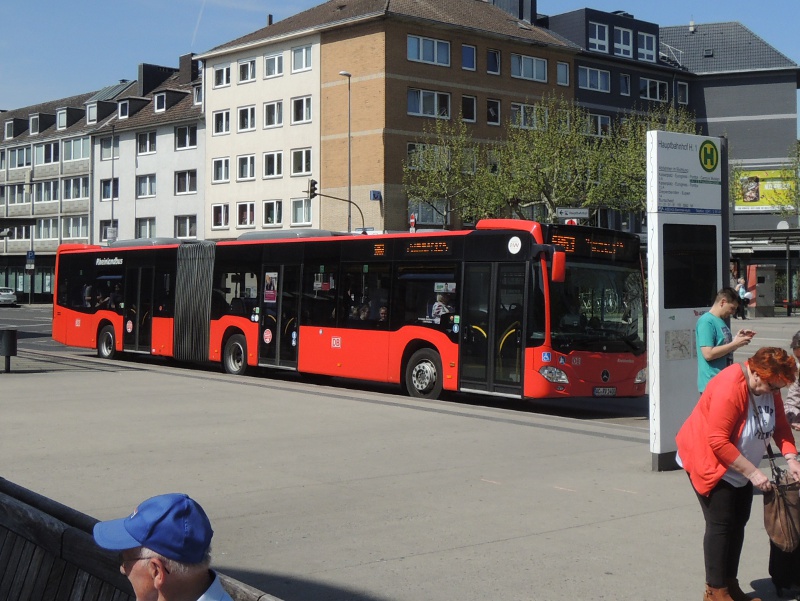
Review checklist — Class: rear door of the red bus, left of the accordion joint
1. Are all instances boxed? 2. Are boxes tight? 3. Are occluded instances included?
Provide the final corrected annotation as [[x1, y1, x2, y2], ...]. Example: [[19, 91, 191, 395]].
[[122, 267, 153, 353]]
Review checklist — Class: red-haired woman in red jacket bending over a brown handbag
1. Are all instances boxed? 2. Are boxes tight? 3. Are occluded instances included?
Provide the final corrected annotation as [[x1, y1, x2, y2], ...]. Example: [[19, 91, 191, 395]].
[[676, 347, 800, 601]]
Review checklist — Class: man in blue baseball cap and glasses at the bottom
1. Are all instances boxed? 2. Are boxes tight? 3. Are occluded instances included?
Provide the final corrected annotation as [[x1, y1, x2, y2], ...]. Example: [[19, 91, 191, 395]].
[[94, 493, 232, 601]]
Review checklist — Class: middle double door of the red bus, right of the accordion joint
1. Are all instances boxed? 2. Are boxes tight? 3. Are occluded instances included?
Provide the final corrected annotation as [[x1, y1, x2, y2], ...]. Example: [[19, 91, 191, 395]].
[[258, 265, 300, 368]]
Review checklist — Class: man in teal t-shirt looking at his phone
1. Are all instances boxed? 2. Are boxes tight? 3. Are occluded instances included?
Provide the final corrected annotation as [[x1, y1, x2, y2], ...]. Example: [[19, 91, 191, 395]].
[[695, 287, 756, 392]]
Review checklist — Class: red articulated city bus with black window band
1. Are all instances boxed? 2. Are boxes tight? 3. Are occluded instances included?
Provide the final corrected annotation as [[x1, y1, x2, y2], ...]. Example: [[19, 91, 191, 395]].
[[53, 219, 646, 399]]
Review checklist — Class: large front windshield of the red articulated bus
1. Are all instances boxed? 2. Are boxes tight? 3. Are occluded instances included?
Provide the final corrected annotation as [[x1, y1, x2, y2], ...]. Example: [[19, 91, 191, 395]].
[[550, 262, 646, 355]]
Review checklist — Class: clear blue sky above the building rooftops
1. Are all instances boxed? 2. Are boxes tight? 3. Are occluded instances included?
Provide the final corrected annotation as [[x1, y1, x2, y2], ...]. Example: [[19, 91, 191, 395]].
[[0, 0, 800, 109]]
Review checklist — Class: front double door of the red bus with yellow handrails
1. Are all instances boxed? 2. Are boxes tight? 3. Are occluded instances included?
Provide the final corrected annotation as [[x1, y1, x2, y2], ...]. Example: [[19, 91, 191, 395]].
[[460, 263, 526, 397]]
